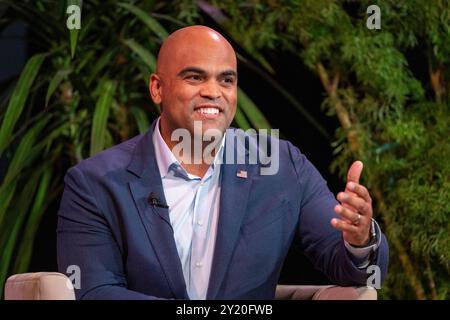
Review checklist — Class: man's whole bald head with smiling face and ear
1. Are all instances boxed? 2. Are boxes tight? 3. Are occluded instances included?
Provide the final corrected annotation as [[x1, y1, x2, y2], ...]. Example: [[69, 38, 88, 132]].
[[149, 26, 237, 146]]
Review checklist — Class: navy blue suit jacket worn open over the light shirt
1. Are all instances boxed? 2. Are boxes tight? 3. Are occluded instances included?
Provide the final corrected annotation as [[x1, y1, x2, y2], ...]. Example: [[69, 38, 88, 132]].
[[57, 124, 388, 299]]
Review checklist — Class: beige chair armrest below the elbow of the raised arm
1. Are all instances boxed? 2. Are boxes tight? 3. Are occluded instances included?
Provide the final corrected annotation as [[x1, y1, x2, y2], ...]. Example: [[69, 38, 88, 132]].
[[275, 285, 377, 300]]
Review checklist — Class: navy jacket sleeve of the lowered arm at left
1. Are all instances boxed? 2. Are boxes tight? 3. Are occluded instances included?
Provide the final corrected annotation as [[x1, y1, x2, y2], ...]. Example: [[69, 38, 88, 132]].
[[57, 167, 168, 300]]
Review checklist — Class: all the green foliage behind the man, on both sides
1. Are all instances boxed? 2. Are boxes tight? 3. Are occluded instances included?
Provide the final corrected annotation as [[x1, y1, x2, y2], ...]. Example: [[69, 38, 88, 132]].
[[0, 0, 450, 299]]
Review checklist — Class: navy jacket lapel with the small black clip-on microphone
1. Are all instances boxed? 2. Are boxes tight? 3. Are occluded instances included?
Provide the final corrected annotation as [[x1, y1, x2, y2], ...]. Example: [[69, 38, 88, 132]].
[[128, 121, 189, 299]]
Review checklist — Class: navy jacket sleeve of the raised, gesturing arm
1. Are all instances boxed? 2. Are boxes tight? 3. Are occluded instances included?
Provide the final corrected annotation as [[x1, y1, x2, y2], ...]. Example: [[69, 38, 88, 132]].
[[288, 143, 389, 286]]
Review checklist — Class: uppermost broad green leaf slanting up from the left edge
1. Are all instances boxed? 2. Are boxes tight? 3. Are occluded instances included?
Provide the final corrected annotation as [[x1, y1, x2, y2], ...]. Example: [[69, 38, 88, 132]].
[[0, 54, 45, 155]]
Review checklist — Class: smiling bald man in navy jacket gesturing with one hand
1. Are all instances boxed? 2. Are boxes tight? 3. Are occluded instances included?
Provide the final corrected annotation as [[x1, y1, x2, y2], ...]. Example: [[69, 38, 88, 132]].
[[57, 26, 388, 299]]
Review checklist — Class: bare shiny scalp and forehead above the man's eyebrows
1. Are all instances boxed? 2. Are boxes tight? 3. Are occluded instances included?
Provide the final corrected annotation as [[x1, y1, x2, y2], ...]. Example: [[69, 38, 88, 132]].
[[156, 25, 236, 75]]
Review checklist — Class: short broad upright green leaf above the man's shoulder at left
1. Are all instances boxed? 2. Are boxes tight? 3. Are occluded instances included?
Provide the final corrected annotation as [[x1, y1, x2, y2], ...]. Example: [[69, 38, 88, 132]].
[[90, 80, 116, 156]]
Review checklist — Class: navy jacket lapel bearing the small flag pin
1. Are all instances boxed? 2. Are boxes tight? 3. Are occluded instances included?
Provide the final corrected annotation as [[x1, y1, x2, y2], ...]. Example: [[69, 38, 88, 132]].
[[207, 134, 258, 299]]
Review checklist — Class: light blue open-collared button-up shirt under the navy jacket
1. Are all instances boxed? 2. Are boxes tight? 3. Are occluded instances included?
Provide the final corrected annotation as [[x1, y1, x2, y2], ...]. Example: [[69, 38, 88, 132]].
[[153, 119, 225, 299]]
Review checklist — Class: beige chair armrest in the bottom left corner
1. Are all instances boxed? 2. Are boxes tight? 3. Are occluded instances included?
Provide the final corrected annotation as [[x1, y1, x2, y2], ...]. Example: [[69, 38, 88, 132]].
[[5, 272, 75, 300]]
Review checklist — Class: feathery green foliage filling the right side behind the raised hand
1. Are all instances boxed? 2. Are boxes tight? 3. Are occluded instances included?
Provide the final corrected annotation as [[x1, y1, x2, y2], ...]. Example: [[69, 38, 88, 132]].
[[202, 0, 450, 299]]
